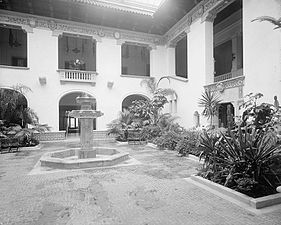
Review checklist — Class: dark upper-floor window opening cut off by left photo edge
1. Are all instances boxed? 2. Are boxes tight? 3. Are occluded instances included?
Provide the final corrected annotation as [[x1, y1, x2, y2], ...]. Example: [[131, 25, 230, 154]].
[[0, 24, 27, 67]]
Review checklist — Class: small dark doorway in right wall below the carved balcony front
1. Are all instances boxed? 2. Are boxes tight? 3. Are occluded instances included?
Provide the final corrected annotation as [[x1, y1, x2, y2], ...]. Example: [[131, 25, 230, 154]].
[[219, 102, 234, 128]]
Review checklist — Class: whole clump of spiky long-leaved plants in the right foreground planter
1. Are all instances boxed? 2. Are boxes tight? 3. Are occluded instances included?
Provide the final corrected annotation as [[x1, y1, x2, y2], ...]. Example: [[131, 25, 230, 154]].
[[200, 127, 281, 196]]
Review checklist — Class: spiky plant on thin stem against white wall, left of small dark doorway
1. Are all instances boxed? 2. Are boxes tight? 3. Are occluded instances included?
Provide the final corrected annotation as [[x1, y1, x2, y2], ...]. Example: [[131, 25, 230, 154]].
[[199, 90, 221, 127]]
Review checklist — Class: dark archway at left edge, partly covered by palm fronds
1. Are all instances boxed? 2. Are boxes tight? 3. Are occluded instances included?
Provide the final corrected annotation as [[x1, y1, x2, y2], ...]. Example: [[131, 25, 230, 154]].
[[0, 88, 27, 127]]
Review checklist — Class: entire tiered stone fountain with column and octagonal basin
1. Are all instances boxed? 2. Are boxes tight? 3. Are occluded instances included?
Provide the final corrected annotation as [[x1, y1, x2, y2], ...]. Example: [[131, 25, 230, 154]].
[[40, 96, 129, 169]]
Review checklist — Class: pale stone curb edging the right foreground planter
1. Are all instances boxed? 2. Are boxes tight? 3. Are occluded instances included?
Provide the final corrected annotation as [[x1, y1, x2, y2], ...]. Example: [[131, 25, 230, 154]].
[[187, 175, 281, 209]]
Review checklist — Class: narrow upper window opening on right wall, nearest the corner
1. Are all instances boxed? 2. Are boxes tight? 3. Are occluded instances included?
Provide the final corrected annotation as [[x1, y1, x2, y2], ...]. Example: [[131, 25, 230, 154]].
[[175, 36, 187, 78]]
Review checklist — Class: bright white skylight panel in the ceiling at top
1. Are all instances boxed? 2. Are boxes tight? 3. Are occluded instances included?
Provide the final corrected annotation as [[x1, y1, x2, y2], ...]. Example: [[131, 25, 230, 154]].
[[83, 0, 166, 16]]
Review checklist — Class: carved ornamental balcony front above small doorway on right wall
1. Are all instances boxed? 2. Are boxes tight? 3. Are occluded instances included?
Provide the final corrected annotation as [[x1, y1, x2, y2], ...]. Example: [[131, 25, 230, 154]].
[[204, 76, 245, 92]]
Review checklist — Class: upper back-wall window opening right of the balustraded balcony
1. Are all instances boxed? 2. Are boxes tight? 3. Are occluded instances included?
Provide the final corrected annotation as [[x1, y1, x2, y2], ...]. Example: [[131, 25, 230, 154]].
[[121, 43, 150, 76]]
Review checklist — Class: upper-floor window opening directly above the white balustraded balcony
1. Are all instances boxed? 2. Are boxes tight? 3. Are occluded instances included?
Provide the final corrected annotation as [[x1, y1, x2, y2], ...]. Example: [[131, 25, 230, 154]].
[[59, 34, 96, 71]]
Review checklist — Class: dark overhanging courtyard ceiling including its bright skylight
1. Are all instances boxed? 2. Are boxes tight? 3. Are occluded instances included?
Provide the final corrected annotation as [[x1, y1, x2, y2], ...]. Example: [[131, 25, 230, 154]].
[[0, 0, 200, 35]]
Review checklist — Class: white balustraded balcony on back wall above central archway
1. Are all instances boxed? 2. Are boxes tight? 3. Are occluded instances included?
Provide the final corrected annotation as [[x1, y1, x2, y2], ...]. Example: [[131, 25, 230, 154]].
[[57, 69, 98, 86]]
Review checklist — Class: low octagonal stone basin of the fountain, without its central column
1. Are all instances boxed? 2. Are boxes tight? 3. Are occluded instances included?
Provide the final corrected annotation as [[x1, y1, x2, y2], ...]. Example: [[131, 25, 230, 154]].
[[40, 147, 129, 169]]
